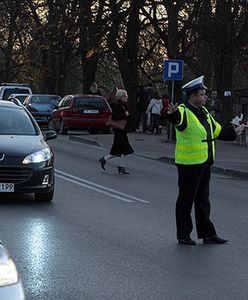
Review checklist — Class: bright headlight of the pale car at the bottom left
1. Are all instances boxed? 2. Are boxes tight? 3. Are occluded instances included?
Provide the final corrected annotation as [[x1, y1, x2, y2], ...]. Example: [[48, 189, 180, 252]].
[[0, 244, 18, 286]]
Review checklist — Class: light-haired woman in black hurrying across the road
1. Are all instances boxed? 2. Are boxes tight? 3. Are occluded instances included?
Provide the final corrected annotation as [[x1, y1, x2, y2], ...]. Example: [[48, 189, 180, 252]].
[[99, 90, 134, 174]]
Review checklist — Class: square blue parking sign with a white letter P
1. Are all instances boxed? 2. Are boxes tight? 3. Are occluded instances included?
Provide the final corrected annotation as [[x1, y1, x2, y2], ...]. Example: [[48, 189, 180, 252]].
[[164, 60, 184, 81]]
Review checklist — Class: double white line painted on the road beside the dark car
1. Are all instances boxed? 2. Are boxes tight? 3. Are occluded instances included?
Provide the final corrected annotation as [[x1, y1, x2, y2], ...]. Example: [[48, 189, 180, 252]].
[[55, 169, 150, 203]]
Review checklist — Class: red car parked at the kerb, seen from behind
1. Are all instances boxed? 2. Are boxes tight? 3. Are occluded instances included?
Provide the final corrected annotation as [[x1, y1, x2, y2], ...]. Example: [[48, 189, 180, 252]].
[[48, 94, 112, 134]]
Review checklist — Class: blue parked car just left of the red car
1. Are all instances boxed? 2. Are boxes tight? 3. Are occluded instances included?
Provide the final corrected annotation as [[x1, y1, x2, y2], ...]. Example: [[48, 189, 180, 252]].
[[23, 94, 61, 126]]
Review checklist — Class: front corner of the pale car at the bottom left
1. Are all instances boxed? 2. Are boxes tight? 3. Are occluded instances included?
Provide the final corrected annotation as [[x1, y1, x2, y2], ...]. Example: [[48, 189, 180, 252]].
[[0, 241, 25, 300]]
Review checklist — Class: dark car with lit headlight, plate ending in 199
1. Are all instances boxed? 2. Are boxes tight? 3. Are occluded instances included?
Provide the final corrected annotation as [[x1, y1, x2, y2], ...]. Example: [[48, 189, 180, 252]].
[[0, 101, 57, 202]]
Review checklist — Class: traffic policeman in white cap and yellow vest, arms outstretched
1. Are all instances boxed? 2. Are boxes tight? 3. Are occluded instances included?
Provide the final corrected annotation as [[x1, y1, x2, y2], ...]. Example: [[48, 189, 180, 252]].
[[167, 76, 244, 245]]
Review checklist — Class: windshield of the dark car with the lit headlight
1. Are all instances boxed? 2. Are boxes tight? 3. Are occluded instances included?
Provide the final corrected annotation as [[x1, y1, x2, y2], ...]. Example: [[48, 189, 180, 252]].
[[0, 107, 37, 135]]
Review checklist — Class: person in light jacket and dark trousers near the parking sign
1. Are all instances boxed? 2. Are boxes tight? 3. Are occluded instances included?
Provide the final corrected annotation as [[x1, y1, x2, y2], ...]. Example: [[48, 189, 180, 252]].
[[146, 92, 163, 134]]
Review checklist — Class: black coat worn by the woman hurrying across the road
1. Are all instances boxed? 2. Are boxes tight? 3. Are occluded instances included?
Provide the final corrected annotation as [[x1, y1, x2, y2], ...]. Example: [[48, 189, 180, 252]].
[[110, 101, 134, 156]]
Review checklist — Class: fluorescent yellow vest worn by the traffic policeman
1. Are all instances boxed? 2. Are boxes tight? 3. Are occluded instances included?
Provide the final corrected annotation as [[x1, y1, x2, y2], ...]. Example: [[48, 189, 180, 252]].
[[175, 104, 221, 165]]
